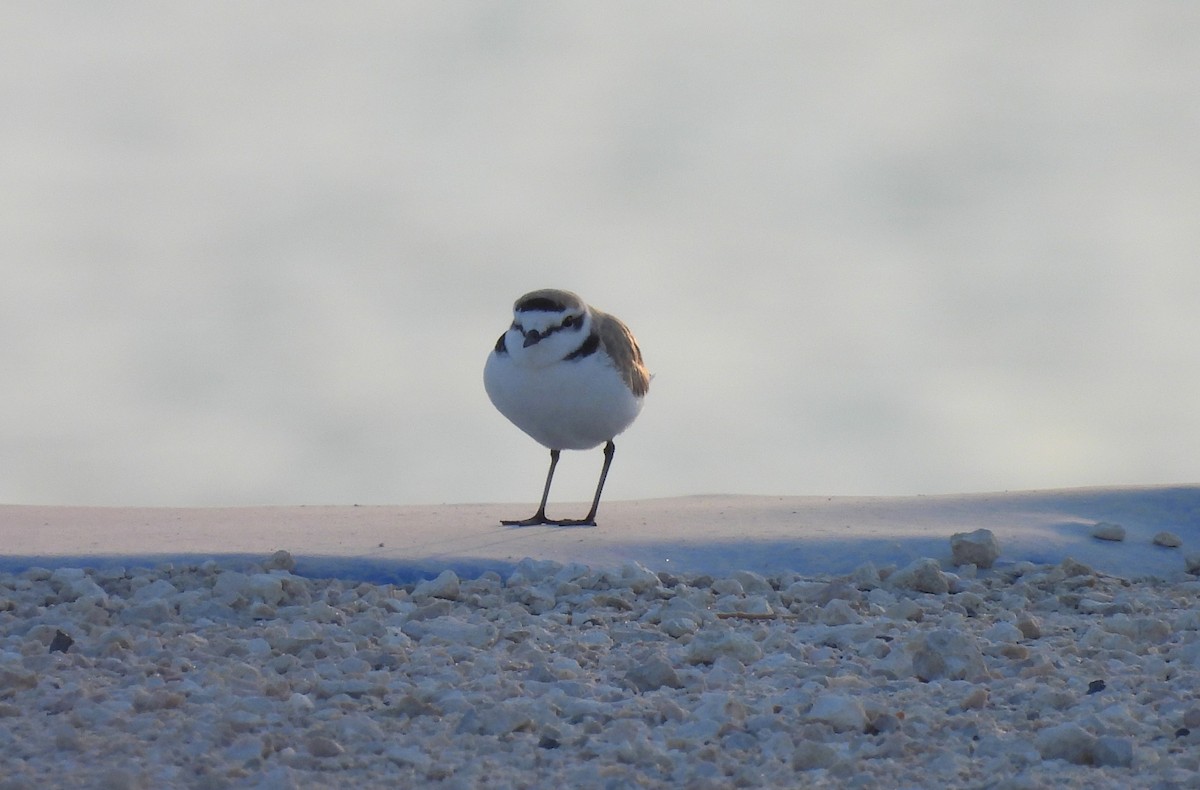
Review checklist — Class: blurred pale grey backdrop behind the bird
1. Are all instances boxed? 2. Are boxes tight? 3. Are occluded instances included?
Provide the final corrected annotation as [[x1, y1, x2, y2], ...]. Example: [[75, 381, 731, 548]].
[[0, 0, 1200, 504]]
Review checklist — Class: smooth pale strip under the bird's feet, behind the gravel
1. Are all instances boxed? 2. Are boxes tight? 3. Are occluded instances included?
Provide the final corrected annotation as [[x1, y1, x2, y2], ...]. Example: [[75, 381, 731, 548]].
[[0, 486, 1200, 576]]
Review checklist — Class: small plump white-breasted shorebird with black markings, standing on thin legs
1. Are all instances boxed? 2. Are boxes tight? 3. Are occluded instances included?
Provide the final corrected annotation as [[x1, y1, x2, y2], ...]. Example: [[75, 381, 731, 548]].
[[484, 288, 650, 527]]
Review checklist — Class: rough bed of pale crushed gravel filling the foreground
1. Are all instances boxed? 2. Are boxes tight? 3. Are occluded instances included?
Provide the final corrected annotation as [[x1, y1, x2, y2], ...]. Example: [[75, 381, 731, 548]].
[[0, 552, 1200, 789]]
